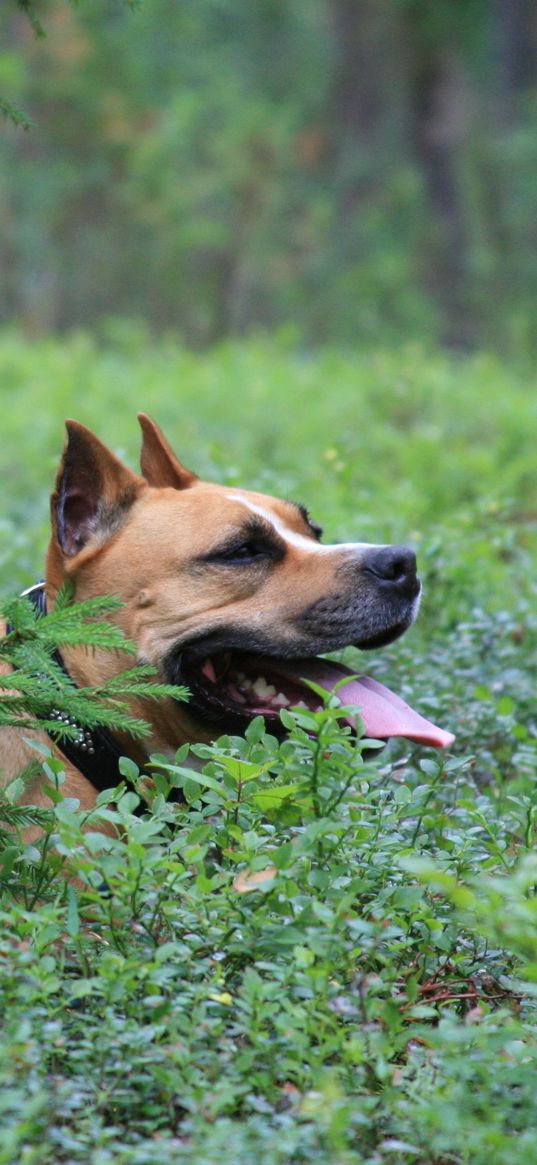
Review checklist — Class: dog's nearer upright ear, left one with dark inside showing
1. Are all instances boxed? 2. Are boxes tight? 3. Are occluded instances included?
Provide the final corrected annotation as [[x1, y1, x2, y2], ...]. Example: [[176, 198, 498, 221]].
[[50, 421, 147, 557]]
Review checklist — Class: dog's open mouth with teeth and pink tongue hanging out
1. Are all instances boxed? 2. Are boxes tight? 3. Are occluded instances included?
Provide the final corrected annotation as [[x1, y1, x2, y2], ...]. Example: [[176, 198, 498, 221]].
[[181, 651, 454, 748]]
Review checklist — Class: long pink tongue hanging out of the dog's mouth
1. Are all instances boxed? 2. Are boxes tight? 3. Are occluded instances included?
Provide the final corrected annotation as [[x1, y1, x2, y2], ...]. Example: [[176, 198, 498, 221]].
[[278, 659, 455, 748]]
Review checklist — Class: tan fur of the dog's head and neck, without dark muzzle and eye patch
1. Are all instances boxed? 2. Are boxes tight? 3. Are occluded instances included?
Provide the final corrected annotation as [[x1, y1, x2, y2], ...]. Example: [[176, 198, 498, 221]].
[[1, 415, 419, 809]]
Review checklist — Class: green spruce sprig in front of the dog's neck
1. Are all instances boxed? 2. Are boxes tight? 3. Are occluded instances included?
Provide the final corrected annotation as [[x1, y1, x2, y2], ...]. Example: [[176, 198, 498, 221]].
[[0, 589, 189, 737]]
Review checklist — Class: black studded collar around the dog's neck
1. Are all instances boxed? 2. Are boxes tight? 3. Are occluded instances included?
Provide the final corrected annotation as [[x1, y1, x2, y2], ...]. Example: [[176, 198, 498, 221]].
[[6, 583, 136, 792]]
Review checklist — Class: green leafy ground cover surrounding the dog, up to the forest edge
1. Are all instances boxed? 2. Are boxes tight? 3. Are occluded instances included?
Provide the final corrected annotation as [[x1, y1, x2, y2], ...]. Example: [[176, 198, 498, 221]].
[[0, 324, 537, 1165]]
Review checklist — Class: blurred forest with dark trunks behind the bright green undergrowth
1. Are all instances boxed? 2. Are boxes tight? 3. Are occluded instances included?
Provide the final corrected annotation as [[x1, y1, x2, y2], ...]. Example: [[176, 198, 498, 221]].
[[0, 0, 537, 355]]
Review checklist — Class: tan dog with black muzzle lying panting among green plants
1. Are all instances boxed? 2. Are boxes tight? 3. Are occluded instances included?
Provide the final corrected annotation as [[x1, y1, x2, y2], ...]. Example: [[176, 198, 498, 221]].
[[2, 414, 453, 809]]
